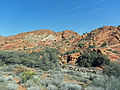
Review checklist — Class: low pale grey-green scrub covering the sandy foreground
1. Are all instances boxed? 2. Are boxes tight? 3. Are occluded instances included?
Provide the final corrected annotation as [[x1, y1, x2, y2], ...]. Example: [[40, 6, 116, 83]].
[[0, 65, 120, 90]]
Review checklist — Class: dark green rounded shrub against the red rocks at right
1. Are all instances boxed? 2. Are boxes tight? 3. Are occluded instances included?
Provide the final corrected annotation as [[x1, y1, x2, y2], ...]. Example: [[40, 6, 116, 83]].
[[77, 52, 110, 67]]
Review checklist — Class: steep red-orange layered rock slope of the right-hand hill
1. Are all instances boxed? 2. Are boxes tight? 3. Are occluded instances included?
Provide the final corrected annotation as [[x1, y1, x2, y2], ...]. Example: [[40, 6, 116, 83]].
[[89, 26, 120, 62]]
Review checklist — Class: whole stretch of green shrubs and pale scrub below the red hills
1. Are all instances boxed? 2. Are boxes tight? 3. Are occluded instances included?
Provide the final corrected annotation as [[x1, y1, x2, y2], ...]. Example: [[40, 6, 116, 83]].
[[0, 48, 120, 90]]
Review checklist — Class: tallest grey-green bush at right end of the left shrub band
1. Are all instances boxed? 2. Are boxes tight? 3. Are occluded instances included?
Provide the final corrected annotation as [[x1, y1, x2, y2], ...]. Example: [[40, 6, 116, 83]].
[[38, 49, 59, 71]]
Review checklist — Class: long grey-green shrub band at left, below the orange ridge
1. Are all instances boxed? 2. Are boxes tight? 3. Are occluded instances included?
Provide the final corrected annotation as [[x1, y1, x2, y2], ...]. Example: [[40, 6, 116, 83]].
[[0, 48, 59, 70]]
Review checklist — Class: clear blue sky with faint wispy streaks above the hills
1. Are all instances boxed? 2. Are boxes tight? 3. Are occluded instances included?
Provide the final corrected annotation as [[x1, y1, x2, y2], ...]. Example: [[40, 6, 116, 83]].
[[0, 0, 120, 36]]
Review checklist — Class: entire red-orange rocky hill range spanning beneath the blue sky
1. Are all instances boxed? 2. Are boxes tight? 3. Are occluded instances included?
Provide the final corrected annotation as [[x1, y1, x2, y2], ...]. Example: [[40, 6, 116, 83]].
[[0, 26, 120, 65]]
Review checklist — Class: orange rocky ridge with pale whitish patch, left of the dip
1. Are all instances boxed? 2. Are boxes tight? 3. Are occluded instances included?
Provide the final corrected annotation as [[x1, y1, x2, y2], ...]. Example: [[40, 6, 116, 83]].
[[0, 29, 81, 52]]
